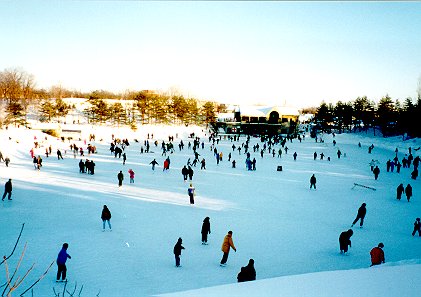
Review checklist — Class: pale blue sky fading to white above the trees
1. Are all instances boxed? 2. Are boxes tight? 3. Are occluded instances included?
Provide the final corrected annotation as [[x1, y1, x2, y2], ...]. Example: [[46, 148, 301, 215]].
[[0, 1, 421, 107]]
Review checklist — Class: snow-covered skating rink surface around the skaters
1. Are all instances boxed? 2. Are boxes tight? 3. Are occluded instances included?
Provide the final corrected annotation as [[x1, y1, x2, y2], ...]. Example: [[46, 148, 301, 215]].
[[0, 126, 421, 296]]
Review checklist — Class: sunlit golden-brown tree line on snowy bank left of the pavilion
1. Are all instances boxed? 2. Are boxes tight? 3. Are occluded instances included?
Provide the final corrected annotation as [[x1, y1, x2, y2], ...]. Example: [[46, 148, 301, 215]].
[[0, 69, 220, 129]]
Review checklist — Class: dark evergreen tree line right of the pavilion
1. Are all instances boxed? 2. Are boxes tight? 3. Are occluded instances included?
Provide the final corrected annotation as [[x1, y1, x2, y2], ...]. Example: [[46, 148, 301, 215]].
[[314, 93, 421, 137]]
